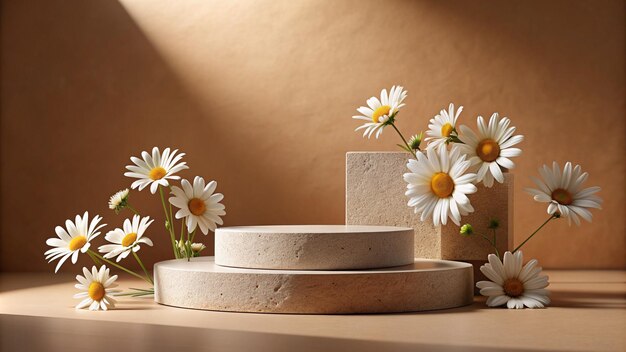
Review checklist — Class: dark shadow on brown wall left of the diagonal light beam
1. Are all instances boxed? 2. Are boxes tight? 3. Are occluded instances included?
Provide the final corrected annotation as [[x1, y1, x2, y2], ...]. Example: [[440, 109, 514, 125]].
[[0, 1, 212, 272]]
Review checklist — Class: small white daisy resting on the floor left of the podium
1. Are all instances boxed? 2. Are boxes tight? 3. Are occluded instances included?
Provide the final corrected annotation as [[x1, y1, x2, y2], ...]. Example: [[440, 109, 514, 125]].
[[74, 265, 120, 310]]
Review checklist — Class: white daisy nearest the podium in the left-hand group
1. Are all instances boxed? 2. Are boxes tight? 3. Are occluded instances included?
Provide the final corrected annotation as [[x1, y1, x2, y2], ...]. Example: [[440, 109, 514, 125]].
[[169, 176, 226, 235]]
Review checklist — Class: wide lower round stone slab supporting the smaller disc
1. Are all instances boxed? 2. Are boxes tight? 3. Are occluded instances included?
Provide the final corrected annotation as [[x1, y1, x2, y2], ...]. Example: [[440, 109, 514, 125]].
[[154, 257, 473, 314]]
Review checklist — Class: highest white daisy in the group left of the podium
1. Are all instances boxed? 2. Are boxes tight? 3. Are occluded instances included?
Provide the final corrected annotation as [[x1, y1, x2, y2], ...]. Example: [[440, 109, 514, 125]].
[[124, 147, 189, 194]]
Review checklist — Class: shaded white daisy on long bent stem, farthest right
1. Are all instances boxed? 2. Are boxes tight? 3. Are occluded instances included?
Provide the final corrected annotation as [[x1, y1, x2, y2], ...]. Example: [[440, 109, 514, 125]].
[[526, 162, 602, 225]]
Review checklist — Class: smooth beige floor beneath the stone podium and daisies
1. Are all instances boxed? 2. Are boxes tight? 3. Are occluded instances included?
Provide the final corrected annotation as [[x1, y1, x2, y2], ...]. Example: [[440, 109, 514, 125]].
[[0, 271, 626, 351]]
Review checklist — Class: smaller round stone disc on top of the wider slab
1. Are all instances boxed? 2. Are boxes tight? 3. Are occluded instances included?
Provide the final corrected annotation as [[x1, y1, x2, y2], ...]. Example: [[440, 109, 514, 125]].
[[215, 225, 414, 270]]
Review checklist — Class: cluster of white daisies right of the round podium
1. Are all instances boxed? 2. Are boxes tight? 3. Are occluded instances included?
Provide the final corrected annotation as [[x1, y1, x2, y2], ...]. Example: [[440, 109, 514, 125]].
[[353, 86, 602, 308]]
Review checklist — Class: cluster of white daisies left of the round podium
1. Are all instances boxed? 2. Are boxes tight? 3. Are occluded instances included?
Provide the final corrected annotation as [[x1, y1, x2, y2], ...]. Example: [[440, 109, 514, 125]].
[[44, 147, 226, 310]]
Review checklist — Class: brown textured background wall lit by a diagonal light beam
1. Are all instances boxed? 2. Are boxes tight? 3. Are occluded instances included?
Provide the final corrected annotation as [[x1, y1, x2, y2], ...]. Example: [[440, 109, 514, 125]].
[[0, 0, 626, 272]]
